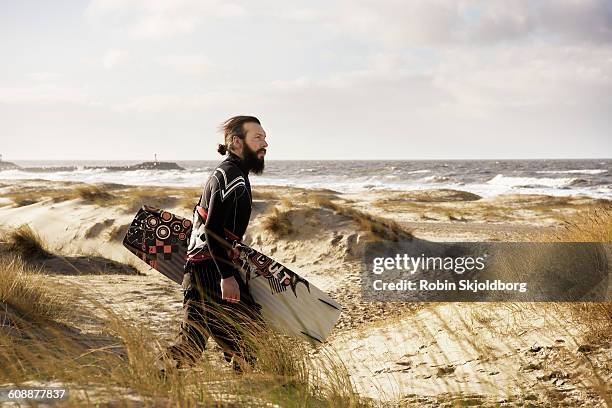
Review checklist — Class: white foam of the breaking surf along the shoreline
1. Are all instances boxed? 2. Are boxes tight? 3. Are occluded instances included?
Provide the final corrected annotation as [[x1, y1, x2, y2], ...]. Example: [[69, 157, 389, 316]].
[[0, 168, 610, 198]]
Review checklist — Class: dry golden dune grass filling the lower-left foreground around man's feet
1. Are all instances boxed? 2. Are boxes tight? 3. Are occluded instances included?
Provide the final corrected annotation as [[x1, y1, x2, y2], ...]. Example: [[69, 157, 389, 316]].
[[0, 242, 371, 407]]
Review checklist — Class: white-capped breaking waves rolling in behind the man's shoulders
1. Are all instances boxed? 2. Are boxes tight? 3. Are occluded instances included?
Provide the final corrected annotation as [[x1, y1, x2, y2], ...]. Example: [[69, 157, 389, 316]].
[[0, 163, 612, 198]]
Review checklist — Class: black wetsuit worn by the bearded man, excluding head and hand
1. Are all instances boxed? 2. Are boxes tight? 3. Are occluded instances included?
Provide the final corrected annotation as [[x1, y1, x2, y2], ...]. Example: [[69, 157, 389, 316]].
[[169, 153, 261, 365]]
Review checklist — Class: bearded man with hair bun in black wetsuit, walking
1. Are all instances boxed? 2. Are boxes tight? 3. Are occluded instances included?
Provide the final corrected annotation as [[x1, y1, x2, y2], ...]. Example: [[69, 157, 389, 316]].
[[166, 116, 268, 371]]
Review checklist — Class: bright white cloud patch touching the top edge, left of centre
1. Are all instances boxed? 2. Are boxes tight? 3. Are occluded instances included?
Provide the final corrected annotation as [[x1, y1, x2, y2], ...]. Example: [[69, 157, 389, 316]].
[[85, 0, 246, 39]]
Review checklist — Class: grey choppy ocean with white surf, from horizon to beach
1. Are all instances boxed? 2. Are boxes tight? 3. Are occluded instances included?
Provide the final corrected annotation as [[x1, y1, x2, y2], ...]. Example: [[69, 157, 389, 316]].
[[0, 159, 612, 199]]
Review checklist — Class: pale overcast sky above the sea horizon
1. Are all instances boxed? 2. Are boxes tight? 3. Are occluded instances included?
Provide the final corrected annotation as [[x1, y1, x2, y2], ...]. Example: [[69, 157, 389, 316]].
[[0, 0, 612, 161]]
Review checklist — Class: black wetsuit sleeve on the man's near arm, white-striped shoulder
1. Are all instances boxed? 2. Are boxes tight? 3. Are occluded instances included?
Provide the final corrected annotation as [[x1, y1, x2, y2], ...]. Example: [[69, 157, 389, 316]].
[[204, 168, 244, 278]]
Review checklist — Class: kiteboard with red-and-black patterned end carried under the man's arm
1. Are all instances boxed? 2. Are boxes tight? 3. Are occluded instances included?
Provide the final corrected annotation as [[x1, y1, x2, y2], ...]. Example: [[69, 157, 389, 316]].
[[123, 205, 342, 343]]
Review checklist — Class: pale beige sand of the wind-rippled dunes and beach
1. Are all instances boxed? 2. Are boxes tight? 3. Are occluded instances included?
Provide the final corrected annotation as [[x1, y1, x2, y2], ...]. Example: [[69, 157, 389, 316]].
[[0, 180, 612, 406]]
